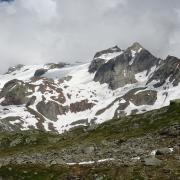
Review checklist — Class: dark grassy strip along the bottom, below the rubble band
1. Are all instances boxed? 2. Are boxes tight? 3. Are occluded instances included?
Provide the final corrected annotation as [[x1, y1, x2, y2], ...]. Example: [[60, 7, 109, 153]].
[[0, 159, 180, 180]]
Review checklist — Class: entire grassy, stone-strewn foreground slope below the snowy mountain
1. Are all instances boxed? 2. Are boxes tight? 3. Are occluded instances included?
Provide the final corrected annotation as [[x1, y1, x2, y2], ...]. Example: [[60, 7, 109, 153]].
[[0, 101, 180, 179]]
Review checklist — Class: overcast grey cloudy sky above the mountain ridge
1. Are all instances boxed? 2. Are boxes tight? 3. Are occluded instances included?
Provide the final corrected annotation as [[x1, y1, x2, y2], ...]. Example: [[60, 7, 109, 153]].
[[0, 0, 180, 72]]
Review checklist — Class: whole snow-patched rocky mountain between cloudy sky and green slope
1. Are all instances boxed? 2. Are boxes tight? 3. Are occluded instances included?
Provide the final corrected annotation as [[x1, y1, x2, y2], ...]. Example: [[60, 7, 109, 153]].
[[0, 43, 180, 133]]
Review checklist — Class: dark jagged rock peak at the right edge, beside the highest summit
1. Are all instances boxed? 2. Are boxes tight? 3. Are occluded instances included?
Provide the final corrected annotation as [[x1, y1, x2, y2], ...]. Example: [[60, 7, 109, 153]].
[[147, 56, 180, 87]]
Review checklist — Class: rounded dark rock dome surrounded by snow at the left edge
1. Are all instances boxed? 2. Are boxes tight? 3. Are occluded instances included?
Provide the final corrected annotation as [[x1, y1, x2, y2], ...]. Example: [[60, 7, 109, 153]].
[[0, 79, 32, 106]]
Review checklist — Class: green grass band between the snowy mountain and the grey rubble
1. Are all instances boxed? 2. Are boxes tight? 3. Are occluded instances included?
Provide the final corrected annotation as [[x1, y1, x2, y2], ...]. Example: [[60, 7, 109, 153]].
[[0, 102, 180, 156]]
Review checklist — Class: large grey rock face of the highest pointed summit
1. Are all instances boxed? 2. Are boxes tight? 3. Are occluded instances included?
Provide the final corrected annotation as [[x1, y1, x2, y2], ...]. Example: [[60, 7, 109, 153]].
[[93, 43, 160, 89]]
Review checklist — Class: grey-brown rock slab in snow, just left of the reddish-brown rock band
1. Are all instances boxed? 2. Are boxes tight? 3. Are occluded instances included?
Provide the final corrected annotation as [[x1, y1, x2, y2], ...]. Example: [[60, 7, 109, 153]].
[[36, 101, 68, 121]]
